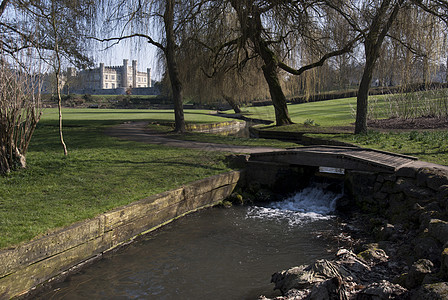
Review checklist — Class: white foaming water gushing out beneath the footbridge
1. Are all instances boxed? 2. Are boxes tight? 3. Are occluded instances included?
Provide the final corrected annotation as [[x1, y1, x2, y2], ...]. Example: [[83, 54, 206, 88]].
[[247, 184, 341, 226]]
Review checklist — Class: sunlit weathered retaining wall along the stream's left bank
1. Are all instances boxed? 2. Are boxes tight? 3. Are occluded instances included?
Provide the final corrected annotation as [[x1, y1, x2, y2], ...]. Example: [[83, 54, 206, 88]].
[[0, 171, 242, 299]]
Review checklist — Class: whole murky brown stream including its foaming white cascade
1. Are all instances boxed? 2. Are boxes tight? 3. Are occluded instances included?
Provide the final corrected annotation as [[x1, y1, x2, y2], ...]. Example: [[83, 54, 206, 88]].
[[36, 187, 338, 299]]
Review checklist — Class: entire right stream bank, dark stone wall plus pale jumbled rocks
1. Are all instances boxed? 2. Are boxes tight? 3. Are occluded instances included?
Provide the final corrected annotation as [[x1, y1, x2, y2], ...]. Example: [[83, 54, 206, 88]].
[[260, 162, 448, 300]]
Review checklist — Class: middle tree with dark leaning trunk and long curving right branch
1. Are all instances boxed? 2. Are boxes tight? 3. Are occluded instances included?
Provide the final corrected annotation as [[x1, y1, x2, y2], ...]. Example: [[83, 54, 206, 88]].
[[190, 0, 357, 126]]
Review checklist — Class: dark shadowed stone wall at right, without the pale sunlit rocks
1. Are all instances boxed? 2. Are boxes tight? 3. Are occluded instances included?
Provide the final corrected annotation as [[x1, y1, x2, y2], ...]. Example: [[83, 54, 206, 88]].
[[346, 162, 448, 288]]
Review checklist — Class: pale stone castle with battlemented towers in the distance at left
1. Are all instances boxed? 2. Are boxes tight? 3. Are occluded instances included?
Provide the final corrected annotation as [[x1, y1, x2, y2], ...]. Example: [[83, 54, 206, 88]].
[[64, 59, 157, 95]]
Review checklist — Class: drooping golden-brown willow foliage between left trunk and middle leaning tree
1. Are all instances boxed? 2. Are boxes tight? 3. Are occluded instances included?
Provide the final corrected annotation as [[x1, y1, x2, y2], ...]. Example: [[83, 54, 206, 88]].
[[179, 3, 269, 113]]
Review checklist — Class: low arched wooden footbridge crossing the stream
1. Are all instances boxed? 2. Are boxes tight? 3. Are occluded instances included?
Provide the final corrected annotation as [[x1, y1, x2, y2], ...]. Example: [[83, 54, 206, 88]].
[[249, 146, 417, 173]]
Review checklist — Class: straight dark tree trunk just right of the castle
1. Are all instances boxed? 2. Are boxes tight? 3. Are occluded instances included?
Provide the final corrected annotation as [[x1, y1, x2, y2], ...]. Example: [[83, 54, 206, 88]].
[[163, 0, 185, 133]]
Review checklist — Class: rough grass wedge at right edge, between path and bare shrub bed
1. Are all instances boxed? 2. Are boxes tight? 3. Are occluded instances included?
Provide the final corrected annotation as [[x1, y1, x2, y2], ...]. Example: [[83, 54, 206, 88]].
[[310, 130, 448, 165]]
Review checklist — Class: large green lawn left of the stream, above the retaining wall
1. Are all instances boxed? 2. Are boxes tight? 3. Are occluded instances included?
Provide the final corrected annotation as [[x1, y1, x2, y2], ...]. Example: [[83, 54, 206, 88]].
[[0, 110, 236, 248]]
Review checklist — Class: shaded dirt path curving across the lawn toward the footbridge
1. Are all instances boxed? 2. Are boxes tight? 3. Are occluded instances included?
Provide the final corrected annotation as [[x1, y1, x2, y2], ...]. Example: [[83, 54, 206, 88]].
[[105, 122, 284, 154]]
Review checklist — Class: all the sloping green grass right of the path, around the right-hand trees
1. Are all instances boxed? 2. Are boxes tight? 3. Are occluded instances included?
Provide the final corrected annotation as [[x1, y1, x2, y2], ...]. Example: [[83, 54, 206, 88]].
[[236, 96, 448, 165]]
